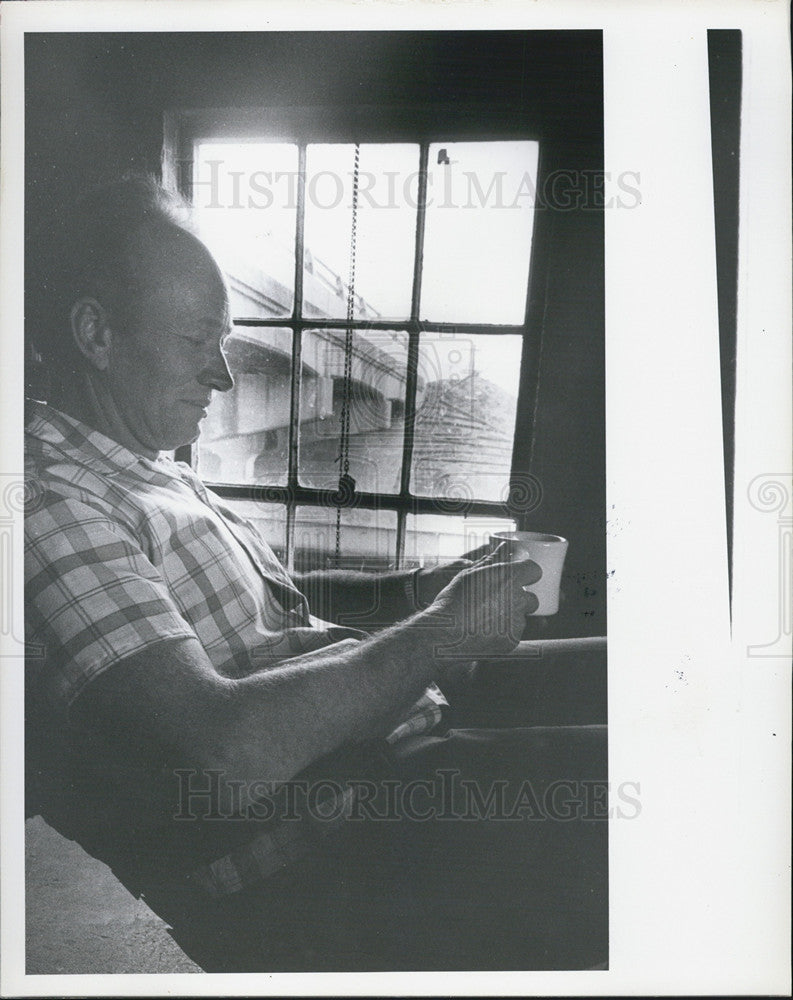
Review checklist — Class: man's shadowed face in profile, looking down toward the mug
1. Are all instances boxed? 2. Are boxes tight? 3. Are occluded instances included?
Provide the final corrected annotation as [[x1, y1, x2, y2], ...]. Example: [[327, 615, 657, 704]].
[[102, 233, 233, 451]]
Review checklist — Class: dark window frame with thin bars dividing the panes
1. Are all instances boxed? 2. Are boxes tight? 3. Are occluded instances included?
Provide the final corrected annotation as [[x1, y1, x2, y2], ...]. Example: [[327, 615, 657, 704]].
[[162, 104, 553, 571]]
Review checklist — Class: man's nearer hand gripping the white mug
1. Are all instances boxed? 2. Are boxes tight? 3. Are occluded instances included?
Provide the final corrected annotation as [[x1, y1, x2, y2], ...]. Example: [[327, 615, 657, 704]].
[[426, 546, 542, 658]]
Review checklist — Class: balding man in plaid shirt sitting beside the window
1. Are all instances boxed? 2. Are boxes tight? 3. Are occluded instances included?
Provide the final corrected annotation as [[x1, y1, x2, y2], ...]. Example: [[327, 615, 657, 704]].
[[26, 179, 606, 971]]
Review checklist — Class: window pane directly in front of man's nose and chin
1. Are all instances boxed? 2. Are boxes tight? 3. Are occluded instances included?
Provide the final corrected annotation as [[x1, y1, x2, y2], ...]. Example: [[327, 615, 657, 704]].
[[198, 326, 292, 486]]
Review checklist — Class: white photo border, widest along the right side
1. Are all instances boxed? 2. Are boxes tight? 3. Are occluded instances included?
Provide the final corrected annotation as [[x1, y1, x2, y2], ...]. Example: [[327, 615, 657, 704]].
[[0, 0, 793, 996]]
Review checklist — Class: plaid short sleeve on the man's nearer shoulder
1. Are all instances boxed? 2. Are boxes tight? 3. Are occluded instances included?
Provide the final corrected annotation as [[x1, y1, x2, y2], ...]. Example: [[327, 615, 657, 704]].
[[25, 497, 196, 709]]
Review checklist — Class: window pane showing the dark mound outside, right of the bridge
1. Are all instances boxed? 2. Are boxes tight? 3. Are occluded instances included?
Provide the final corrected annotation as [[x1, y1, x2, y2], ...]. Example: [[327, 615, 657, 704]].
[[410, 333, 522, 501]]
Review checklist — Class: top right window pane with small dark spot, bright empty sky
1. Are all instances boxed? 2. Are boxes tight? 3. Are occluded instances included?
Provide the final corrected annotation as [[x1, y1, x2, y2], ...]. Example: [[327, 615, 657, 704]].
[[420, 142, 539, 324]]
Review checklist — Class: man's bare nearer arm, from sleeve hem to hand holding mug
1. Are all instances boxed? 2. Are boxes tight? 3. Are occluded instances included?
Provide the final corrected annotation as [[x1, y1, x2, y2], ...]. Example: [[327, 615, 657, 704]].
[[73, 561, 539, 796]]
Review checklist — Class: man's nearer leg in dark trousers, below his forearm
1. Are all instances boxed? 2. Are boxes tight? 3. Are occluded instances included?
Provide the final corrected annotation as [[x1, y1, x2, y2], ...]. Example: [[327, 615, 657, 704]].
[[138, 727, 607, 971]]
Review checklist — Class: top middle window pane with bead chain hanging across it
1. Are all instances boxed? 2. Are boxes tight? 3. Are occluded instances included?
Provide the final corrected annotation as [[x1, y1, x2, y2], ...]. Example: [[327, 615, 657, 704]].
[[303, 143, 419, 319]]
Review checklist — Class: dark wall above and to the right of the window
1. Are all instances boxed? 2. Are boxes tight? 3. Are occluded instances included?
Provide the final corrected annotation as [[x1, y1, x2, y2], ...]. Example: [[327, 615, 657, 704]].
[[26, 31, 605, 634]]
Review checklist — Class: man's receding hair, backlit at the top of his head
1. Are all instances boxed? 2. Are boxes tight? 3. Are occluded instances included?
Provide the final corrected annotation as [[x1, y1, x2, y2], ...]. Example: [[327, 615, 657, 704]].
[[25, 174, 192, 363]]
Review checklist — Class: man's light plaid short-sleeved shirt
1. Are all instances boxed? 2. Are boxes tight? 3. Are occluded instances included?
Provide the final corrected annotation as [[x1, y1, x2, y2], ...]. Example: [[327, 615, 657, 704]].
[[25, 403, 446, 892]]
